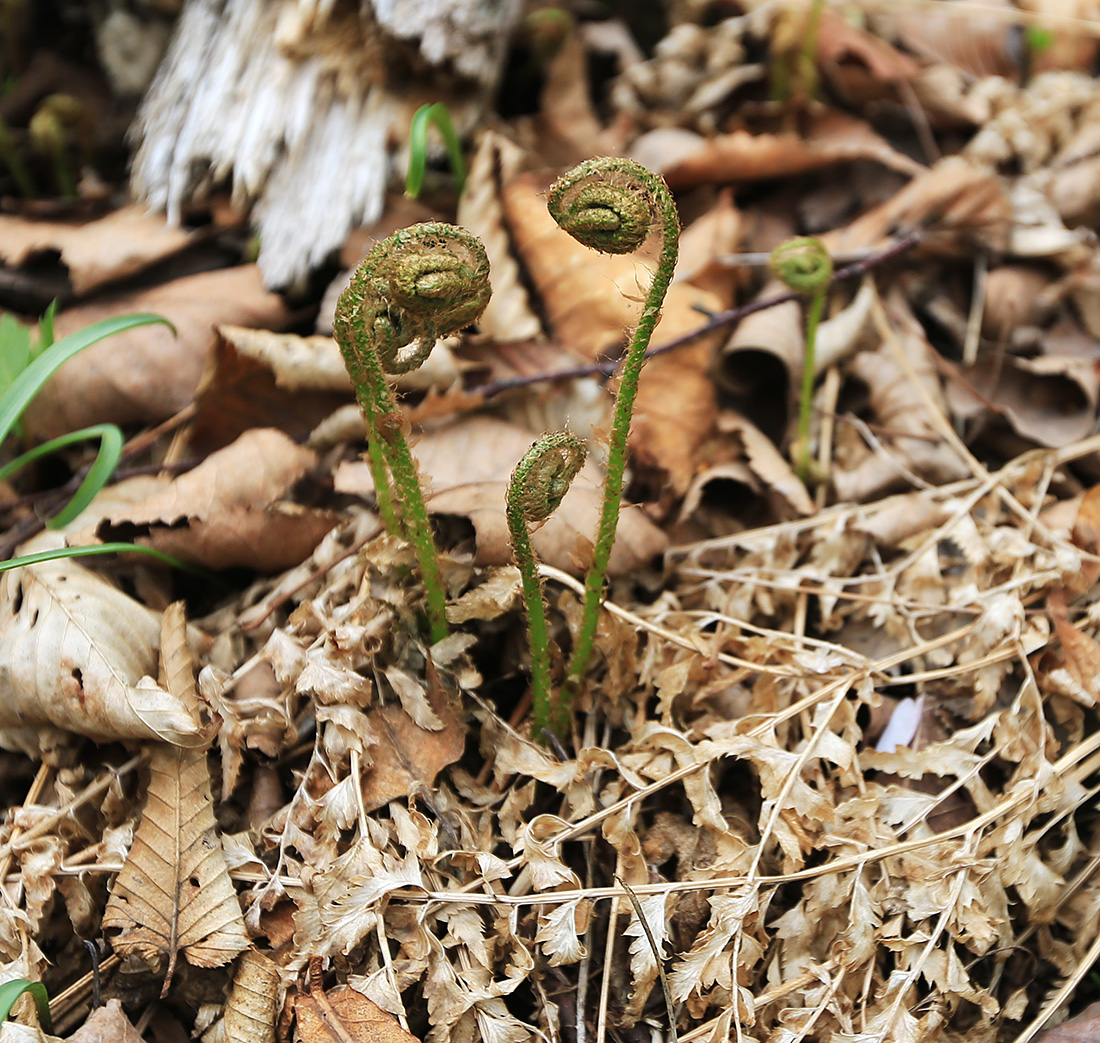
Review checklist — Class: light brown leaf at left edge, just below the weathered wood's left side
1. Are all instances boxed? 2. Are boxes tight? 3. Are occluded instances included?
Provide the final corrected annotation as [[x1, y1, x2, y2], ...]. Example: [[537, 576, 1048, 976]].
[[0, 206, 191, 297]]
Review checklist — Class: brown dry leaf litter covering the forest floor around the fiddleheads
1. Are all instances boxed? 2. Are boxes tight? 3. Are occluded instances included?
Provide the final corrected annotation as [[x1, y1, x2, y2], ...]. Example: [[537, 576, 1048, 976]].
[[0, 2, 1100, 1043]]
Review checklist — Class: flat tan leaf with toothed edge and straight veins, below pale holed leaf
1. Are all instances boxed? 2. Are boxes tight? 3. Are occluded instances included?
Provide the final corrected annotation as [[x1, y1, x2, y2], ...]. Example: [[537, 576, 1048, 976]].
[[103, 746, 251, 996]]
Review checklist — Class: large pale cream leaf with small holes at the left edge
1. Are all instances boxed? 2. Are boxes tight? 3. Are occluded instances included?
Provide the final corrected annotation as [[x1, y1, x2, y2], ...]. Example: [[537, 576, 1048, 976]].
[[0, 559, 202, 745]]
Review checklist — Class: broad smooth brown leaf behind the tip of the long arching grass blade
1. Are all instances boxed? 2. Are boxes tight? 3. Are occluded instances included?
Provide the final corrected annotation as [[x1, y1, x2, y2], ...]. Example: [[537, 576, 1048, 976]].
[[26, 265, 289, 439]]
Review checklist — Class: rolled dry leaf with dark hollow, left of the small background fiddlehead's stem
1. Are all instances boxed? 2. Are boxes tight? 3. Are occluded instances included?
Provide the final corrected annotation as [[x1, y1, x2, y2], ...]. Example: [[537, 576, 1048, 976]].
[[715, 279, 806, 443]]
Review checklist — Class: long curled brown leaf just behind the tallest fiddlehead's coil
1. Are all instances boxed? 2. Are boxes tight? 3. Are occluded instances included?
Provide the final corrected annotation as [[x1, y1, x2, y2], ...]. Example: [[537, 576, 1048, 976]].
[[630, 110, 924, 189]]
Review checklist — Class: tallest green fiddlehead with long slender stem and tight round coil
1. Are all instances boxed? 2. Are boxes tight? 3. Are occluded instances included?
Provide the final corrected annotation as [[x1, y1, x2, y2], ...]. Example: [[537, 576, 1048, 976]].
[[547, 157, 680, 702]]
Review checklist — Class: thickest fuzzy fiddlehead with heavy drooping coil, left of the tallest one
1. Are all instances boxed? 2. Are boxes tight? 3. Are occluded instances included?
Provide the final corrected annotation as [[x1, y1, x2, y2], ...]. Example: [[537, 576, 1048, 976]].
[[333, 223, 491, 640]]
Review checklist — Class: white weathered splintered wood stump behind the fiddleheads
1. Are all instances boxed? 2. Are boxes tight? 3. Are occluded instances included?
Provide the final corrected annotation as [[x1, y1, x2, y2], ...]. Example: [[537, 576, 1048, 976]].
[[132, 0, 520, 286]]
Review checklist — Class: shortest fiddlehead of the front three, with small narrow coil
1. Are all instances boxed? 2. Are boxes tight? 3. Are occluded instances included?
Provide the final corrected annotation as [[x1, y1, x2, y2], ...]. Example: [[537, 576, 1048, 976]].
[[506, 431, 587, 738]]
